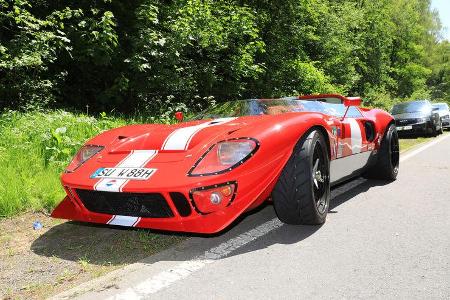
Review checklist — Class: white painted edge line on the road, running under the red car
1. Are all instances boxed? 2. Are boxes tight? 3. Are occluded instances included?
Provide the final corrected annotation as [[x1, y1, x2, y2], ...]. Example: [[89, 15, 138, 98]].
[[105, 135, 450, 300]]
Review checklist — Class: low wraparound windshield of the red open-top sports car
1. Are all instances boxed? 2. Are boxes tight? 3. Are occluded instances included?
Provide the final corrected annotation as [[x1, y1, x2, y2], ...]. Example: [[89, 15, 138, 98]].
[[192, 98, 361, 120]]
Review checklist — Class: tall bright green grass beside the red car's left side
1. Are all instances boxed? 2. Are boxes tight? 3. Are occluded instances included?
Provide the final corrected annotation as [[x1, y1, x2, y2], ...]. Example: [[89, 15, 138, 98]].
[[0, 111, 127, 217]]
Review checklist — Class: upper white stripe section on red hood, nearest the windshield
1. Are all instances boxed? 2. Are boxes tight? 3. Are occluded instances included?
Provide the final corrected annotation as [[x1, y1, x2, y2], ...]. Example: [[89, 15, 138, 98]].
[[162, 118, 236, 150]]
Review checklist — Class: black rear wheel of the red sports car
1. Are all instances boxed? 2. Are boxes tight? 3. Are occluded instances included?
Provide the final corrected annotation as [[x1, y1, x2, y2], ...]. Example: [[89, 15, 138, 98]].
[[365, 124, 400, 181]]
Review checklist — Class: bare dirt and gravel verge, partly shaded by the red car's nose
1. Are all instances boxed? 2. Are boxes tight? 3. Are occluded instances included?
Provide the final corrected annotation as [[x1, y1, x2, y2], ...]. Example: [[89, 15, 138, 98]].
[[0, 213, 186, 299]]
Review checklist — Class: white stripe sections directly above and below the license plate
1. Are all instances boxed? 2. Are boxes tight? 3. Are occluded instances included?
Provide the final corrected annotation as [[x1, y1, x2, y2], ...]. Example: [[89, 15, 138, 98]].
[[94, 150, 158, 192]]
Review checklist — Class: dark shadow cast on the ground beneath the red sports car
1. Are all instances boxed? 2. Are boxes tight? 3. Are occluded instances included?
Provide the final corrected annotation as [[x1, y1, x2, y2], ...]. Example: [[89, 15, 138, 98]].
[[31, 178, 387, 265]]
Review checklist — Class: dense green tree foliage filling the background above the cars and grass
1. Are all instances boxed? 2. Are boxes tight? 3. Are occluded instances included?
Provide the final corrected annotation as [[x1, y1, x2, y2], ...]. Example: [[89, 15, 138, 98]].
[[0, 0, 450, 115]]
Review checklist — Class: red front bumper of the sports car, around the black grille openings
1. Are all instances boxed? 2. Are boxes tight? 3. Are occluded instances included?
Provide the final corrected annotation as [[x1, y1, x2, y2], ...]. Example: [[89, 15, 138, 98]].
[[52, 154, 289, 234]]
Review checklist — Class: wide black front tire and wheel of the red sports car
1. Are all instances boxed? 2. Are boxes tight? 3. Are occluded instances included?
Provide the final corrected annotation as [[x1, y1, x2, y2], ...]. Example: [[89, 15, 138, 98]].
[[272, 130, 330, 225]]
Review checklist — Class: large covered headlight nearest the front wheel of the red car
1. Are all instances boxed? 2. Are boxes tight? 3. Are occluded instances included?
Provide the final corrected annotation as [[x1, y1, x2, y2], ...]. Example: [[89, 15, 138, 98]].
[[188, 138, 259, 176]]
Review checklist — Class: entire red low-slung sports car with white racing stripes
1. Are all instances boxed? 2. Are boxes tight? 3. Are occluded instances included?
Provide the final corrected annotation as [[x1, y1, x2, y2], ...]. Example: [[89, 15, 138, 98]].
[[52, 95, 399, 233]]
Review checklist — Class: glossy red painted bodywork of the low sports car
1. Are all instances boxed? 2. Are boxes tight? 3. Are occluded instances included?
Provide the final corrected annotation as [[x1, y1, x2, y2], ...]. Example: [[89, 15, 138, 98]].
[[52, 95, 393, 233]]
